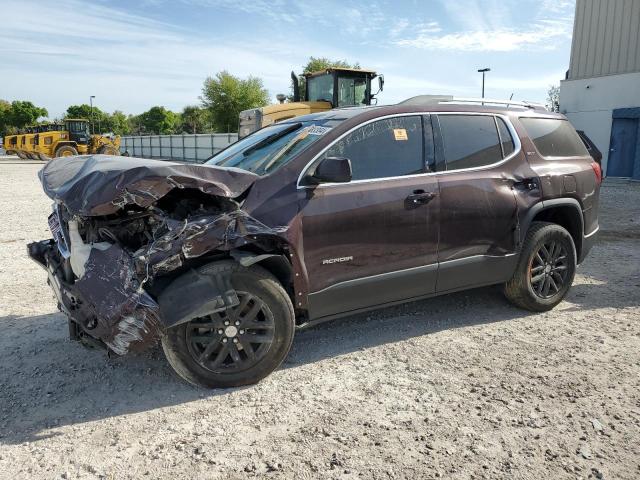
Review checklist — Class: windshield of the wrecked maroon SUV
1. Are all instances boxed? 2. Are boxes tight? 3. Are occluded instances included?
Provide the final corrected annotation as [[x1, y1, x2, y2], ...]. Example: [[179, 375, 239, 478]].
[[206, 119, 342, 175]]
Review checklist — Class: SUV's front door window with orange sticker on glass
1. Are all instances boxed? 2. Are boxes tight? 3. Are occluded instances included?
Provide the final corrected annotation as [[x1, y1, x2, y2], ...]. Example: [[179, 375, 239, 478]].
[[326, 116, 424, 180]]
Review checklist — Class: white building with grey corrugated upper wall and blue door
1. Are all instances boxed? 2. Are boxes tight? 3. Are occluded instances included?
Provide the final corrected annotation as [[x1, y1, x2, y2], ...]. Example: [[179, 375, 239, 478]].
[[560, 0, 640, 180]]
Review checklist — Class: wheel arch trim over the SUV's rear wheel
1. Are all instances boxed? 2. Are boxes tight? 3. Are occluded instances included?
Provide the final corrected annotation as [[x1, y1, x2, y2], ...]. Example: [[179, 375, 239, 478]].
[[520, 198, 584, 258]]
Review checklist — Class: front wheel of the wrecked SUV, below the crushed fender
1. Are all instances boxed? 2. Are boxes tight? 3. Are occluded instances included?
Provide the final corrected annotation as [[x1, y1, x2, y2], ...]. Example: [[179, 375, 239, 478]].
[[162, 260, 295, 388]]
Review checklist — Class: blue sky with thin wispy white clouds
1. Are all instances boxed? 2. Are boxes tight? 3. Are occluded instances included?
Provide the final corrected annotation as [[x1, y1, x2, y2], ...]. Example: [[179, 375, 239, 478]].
[[0, 0, 575, 118]]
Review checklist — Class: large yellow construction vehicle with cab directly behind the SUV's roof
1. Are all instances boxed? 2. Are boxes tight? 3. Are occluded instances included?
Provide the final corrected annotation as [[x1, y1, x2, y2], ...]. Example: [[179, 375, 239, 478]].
[[238, 67, 384, 138]]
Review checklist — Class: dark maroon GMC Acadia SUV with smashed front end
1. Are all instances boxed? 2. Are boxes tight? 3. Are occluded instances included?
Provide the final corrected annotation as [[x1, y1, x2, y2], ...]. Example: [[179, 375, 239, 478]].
[[28, 97, 601, 387]]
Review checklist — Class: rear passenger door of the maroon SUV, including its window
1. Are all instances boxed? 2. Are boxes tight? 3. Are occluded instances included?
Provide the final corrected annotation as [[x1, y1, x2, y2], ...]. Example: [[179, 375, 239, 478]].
[[437, 113, 533, 292]]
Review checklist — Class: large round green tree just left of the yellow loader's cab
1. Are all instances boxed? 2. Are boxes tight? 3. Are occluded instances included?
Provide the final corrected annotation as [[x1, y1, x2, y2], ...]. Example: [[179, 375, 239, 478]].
[[200, 71, 269, 132]]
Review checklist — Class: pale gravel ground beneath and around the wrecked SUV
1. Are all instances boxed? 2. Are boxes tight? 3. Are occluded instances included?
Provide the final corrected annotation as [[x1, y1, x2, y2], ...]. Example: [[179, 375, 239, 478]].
[[0, 159, 640, 480]]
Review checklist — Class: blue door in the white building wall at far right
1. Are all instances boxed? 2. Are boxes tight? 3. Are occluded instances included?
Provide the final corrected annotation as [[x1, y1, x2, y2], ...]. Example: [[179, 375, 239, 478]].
[[607, 118, 638, 177]]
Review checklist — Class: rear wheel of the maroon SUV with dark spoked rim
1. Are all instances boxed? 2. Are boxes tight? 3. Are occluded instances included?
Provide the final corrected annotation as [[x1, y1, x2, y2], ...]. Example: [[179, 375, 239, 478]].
[[504, 222, 577, 312]]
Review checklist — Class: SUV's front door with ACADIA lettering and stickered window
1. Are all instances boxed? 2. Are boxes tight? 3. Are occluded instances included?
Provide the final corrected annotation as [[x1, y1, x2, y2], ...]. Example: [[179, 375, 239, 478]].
[[301, 115, 439, 318]]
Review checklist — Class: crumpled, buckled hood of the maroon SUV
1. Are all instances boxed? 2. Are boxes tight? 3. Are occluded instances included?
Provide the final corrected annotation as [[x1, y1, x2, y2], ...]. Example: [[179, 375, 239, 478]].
[[38, 155, 259, 216]]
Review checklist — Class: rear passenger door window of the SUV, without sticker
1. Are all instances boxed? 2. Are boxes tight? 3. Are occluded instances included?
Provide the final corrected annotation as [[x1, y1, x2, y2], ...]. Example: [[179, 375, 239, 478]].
[[438, 115, 502, 170]]
